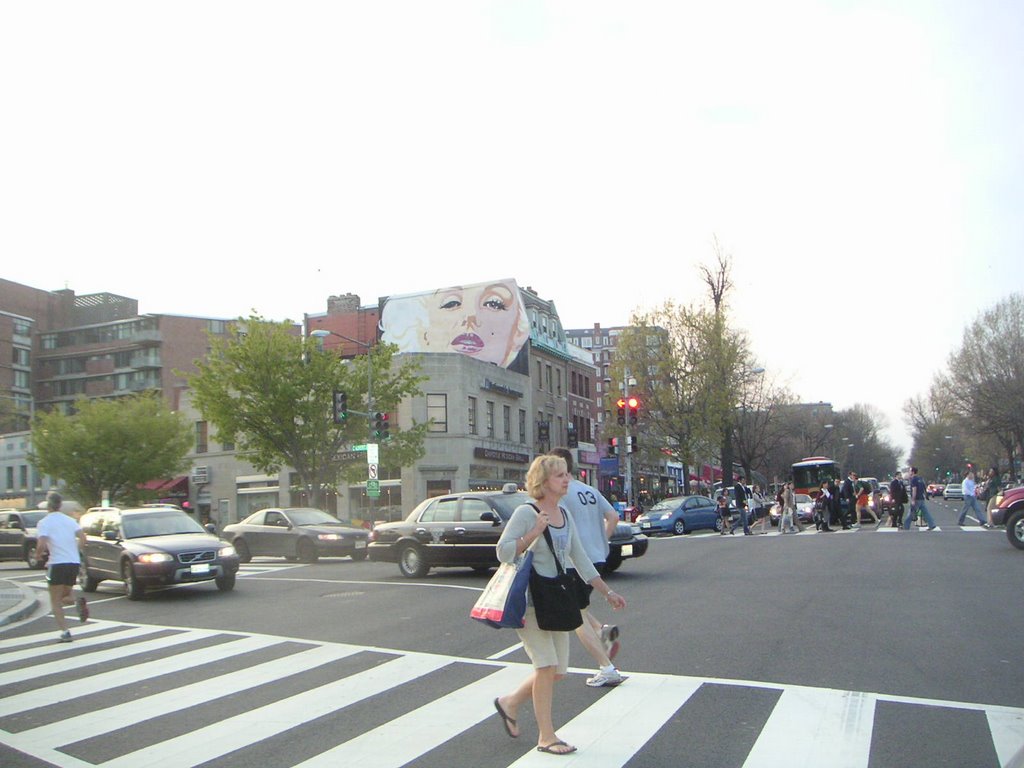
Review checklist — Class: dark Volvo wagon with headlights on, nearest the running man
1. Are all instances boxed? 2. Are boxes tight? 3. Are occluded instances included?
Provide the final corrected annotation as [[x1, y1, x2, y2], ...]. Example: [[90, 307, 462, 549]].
[[78, 508, 239, 600]]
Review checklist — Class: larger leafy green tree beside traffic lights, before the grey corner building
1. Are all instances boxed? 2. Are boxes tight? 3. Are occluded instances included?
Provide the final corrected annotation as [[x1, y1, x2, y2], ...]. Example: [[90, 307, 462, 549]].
[[183, 315, 427, 507]]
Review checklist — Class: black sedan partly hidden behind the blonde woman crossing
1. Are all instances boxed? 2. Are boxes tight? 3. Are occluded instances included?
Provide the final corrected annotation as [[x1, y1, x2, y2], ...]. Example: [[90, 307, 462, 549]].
[[369, 483, 647, 579]]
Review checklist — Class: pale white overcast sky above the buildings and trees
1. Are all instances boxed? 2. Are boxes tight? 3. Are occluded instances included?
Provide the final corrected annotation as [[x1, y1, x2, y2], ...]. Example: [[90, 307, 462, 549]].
[[0, 0, 1024, 460]]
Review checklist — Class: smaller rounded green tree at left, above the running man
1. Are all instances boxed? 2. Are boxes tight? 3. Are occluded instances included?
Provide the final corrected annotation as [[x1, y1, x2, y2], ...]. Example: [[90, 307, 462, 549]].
[[31, 393, 193, 507]]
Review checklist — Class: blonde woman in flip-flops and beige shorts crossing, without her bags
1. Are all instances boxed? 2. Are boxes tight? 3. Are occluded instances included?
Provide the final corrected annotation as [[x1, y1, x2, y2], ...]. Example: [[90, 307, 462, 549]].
[[495, 456, 626, 755]]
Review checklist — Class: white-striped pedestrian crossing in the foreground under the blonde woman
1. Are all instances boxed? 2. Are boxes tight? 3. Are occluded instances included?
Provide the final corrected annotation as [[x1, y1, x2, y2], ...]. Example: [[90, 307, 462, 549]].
[[0, 621, 1024, 768]]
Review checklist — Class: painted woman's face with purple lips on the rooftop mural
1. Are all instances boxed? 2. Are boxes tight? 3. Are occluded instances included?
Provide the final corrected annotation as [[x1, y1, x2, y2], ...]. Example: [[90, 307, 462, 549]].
[[426, 283, 521, 366]]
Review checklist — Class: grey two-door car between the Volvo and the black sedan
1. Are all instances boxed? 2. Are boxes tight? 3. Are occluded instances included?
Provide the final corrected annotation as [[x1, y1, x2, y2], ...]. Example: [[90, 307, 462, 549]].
[[222, 507, 370, 562]]
